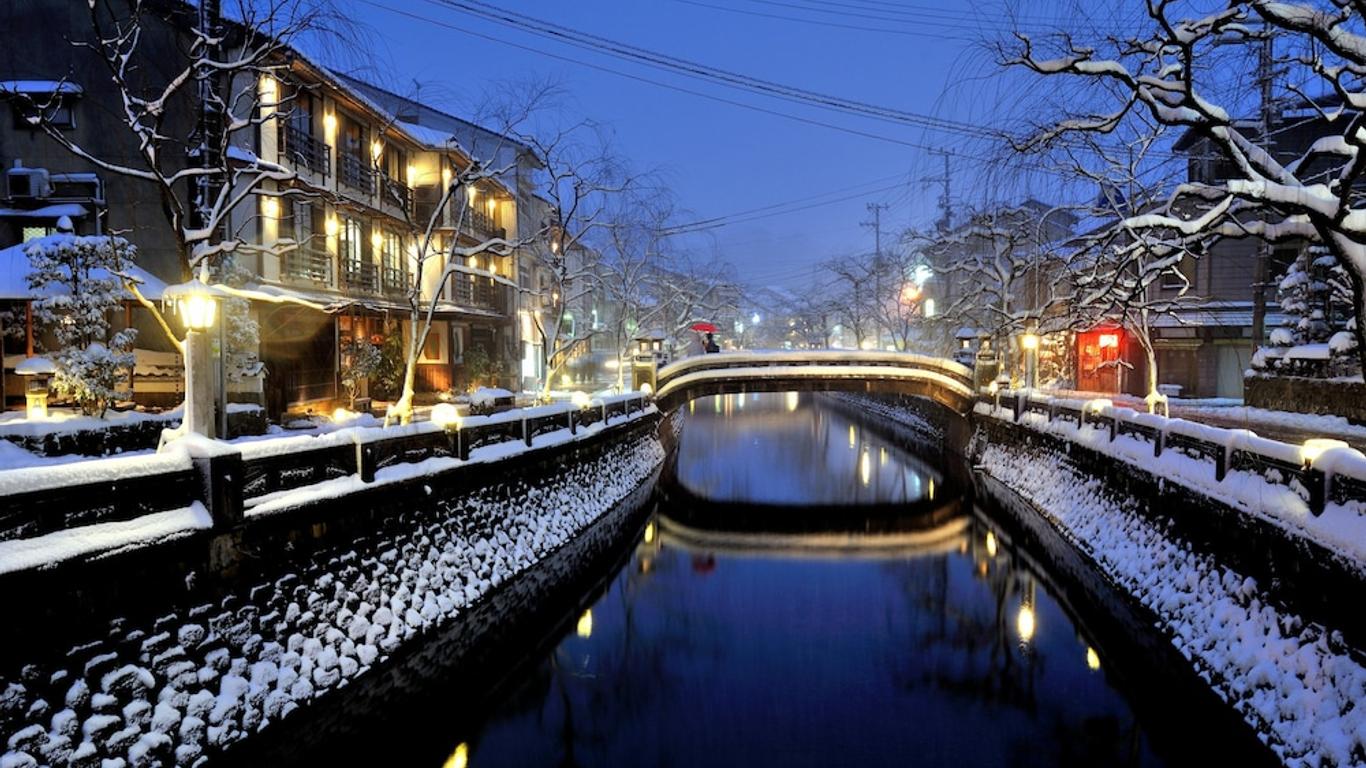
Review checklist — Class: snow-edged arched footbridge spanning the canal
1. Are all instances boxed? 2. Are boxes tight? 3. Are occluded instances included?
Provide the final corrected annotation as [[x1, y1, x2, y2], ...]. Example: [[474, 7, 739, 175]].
[[654, 350, 973, 413]]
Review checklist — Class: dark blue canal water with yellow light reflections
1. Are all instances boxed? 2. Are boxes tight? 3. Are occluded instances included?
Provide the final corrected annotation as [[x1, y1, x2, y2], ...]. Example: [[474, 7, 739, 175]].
[[433, 395, 1165, 768]]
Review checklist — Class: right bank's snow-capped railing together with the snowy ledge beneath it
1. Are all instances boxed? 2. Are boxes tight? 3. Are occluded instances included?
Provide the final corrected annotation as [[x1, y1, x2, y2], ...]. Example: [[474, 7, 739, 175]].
[[977, 392, 1366, 552]]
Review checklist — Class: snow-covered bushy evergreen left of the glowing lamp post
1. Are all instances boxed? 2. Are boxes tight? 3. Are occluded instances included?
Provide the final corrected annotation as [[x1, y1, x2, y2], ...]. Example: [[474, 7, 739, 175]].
[[25, 234, 138, 417]]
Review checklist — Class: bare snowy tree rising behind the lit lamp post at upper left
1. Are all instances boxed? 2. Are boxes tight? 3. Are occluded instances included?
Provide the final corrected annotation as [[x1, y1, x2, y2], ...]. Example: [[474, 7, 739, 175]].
[[19, 0, 346, 348]]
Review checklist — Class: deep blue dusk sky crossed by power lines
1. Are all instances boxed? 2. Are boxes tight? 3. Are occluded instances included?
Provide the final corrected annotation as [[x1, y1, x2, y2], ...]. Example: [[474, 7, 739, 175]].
[[325, 0, 1191, 288]]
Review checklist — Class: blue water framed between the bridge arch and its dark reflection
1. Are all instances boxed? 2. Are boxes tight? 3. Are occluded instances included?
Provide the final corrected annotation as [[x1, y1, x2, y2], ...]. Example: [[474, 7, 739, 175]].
[[676, 392, 940, 506]]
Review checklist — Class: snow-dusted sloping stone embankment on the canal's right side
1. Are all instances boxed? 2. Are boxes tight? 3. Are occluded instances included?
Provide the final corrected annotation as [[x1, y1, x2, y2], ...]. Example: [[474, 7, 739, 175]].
[[981, 445, 1366, 767]]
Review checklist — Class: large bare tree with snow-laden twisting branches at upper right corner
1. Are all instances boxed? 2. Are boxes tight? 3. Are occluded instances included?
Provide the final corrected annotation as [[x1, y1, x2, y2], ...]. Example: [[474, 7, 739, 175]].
[[1003, 0, 1366, 371]]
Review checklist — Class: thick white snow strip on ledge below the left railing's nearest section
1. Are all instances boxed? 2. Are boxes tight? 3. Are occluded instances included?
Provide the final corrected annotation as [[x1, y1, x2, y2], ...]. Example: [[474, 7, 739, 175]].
[[0, 502, 213, 574]]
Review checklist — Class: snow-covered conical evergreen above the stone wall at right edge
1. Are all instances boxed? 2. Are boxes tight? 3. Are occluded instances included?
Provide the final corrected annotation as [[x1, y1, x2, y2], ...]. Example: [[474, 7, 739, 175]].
[[1253, 246, 1359, 376]]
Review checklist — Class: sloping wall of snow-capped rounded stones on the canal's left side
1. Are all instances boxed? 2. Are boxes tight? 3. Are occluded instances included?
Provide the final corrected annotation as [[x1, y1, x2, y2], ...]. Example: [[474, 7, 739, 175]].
[[0, 437, 664, 767]]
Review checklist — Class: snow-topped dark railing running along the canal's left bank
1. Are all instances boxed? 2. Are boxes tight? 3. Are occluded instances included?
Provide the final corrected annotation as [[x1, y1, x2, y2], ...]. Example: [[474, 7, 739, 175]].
[[0, 392, 650, 543]]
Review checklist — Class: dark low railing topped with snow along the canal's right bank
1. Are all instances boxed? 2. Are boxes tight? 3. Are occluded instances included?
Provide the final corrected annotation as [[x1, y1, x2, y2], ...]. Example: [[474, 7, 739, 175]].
[[978, 391, 1366, 517]]
